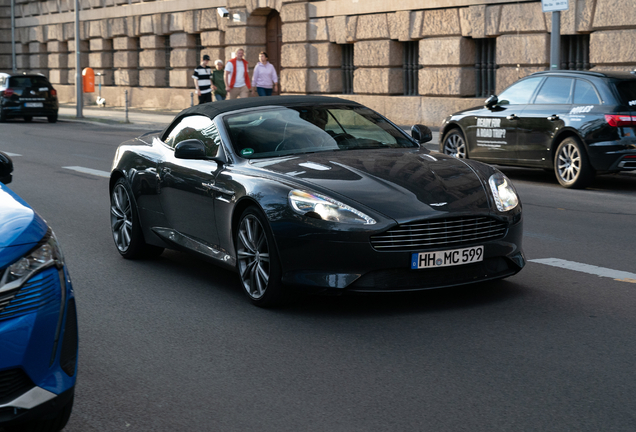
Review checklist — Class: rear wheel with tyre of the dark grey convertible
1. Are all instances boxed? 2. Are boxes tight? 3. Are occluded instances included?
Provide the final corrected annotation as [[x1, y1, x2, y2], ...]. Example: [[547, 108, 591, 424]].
[[110, 178, 164, 259]]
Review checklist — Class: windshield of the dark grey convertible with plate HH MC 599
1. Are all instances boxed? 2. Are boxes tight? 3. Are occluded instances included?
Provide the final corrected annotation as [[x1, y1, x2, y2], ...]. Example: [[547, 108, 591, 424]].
[[225, 105, 418, 159]]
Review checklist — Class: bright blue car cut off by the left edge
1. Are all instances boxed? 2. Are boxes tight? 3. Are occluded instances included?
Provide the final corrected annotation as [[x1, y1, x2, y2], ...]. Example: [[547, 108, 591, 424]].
[[0, 153, 78, 432]]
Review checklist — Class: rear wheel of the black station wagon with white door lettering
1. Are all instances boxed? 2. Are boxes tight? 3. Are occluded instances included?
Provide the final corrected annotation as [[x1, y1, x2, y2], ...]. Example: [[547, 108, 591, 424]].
[[554, 137, 594, 189]]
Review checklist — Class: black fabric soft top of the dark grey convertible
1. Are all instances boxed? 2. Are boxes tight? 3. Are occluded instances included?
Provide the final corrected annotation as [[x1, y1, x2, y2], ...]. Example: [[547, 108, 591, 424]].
[[161, 96, 361, 136]]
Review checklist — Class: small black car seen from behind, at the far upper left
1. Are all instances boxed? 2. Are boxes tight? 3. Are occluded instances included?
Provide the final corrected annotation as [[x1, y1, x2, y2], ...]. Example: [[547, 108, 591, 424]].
[[0, 73, 59, 123]]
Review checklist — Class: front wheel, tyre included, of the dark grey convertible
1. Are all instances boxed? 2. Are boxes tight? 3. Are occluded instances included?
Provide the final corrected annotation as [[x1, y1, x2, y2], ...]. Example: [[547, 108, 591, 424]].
[[234, 207, 286, 307]]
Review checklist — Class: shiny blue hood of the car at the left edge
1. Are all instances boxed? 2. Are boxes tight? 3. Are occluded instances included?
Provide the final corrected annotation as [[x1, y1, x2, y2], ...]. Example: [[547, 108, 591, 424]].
[[0, 183, 48, 269]]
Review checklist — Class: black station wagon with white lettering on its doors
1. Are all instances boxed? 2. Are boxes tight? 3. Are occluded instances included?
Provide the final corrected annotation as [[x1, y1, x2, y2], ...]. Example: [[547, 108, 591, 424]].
[[440, 71, 636, 188]]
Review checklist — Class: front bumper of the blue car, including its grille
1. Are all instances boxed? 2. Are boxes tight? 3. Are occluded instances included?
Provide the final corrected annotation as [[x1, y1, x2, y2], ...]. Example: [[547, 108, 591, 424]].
[[0, 267, 78, 425]]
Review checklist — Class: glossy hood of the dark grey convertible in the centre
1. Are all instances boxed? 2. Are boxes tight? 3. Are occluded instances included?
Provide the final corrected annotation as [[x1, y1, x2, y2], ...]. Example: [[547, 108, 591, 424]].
[[253, 149, 490, 222]]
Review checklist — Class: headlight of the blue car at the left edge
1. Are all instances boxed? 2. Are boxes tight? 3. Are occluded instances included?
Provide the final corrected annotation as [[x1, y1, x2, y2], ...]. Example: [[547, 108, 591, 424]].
[[0, 231, 64, 289]]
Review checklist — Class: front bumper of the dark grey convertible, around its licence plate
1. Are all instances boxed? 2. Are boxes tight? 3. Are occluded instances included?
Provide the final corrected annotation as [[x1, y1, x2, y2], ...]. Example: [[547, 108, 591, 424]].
[[275, 214, 526, 292]]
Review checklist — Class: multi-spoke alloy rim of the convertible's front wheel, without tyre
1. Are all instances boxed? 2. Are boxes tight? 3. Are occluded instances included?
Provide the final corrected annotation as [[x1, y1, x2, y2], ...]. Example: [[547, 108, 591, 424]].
[[237, 214, 270, 300]]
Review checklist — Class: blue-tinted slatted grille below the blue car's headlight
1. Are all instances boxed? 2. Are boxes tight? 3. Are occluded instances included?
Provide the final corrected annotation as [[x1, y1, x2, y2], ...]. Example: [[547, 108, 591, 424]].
[[0, 269, 61, 321]]
